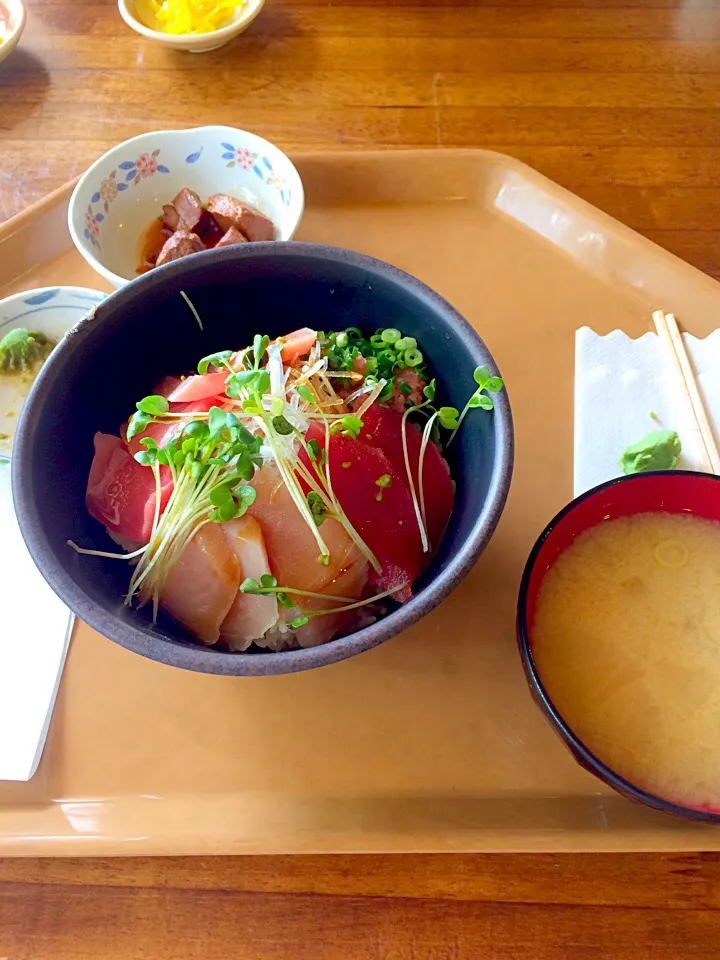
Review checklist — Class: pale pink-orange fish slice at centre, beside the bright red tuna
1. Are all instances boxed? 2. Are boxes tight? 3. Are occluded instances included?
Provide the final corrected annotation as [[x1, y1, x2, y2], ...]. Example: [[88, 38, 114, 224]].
[[248, 464, 362, 592]]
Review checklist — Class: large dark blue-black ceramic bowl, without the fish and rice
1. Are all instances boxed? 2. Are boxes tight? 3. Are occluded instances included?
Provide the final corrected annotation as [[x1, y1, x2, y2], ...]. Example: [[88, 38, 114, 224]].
[[12, 243, 513, 676]]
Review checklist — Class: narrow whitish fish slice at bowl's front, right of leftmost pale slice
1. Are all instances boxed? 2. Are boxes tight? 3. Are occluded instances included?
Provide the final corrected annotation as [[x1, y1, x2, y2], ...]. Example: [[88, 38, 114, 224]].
[[220, 516, 278, 650]]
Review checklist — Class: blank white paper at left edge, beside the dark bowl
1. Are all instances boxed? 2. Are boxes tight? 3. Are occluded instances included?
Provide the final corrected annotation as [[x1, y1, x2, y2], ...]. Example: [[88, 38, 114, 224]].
[[0, 462, 73, 780]]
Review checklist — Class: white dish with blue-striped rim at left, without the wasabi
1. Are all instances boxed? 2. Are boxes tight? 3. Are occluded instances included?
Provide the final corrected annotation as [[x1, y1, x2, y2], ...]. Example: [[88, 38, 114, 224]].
[[0, 287, 106, 460]]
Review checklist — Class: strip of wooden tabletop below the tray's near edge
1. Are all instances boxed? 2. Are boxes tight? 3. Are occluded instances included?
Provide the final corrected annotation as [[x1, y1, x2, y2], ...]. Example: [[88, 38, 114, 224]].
[[0, 854, 720, 960]]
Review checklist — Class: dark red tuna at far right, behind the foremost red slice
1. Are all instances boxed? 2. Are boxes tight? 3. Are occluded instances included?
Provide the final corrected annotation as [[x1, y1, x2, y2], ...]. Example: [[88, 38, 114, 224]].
[[360, 403, 455, 550]]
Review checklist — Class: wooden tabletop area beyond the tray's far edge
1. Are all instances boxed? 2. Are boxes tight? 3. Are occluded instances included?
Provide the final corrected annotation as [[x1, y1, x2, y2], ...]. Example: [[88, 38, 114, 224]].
[[0, 0, 720, 275]]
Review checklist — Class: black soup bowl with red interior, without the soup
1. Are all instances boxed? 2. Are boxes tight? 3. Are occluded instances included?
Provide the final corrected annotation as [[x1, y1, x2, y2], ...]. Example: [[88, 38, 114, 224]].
[[517, 470, 720, 823]]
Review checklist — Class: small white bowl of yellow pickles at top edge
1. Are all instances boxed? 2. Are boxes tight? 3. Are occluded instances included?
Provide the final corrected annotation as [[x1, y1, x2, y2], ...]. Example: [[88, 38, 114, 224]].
[[118, 0, 265, 53]]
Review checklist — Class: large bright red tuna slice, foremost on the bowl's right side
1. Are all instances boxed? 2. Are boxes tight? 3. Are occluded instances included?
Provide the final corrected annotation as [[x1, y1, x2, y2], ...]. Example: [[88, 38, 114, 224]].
[[302, 423, 422, 603]]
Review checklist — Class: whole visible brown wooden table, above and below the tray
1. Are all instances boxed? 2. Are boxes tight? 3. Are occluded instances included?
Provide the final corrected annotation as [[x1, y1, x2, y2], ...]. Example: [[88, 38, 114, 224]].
[[0, 0, 720, 960]]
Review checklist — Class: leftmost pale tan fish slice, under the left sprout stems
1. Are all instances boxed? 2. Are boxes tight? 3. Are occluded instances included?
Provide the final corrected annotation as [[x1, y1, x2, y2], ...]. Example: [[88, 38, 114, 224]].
[[160, 523, 241, 644]]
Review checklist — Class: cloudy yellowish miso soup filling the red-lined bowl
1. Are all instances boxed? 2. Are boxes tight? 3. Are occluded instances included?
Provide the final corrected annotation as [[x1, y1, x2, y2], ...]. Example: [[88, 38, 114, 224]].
[[532, 513, 720, 807]]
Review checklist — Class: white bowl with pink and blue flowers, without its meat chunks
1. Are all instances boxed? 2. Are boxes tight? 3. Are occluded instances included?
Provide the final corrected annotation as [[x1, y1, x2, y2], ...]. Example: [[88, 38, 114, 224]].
[[68, 127, 305, 287]]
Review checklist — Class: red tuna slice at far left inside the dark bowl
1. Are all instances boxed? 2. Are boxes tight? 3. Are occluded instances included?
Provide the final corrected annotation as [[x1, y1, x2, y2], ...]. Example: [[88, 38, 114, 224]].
[[85, 433, 171, 543]]
